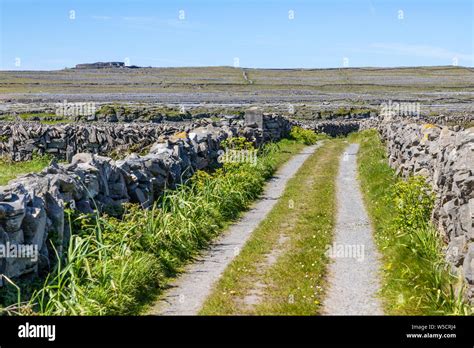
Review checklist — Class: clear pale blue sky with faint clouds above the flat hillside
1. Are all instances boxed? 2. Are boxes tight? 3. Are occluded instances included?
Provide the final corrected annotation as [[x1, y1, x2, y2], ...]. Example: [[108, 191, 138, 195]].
[[0, 0, 474, 70]]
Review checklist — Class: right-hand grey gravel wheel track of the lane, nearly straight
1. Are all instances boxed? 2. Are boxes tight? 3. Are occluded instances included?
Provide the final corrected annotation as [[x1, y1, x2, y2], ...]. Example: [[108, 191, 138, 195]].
[[322, 144, 383, 315]]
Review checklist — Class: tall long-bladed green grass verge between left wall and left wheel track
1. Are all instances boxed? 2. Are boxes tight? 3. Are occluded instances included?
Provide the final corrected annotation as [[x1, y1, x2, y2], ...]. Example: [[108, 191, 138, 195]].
[[4, 140, 312, 315]]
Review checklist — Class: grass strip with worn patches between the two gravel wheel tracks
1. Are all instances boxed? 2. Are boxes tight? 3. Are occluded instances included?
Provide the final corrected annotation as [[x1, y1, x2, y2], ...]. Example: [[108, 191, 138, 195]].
[[200, 140, 345, 315]]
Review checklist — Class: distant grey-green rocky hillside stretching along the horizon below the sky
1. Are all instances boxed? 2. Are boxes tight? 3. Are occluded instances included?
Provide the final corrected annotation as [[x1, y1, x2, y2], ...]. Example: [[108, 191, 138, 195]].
[[0, 66, 474, 103]]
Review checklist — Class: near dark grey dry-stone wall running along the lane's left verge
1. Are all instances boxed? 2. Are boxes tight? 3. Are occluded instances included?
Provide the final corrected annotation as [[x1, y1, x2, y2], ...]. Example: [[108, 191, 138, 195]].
[[0, 115, 291, 284]]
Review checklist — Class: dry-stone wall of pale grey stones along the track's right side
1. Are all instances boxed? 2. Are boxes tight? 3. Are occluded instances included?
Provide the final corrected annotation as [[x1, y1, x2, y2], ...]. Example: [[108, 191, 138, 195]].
[[378, 118, 474, 300]]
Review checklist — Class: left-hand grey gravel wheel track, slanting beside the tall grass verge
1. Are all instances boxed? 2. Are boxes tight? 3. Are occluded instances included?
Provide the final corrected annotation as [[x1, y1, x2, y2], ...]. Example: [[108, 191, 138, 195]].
[[148, 143, 321, 315]]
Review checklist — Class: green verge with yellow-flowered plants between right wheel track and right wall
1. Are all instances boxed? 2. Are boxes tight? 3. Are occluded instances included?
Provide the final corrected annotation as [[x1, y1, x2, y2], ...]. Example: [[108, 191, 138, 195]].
[[351, 130, 471, 315]]
